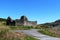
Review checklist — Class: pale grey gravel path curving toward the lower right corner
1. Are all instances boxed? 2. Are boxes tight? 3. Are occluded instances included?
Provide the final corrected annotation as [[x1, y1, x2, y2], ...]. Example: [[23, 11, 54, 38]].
[[13, 29, 60, 40]]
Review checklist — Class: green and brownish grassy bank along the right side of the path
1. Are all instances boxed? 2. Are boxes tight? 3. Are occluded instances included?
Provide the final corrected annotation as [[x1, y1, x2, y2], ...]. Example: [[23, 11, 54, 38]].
[[38, 28, 60, 38]]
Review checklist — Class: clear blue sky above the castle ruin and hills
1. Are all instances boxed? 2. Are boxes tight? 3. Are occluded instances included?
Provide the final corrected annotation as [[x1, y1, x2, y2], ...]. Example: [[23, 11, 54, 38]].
[[0, 0, 60, 24]]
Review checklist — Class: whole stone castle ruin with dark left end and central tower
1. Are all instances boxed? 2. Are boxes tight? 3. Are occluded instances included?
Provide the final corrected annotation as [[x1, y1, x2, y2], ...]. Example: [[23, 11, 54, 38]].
[[6, 16, 37, 26]]
